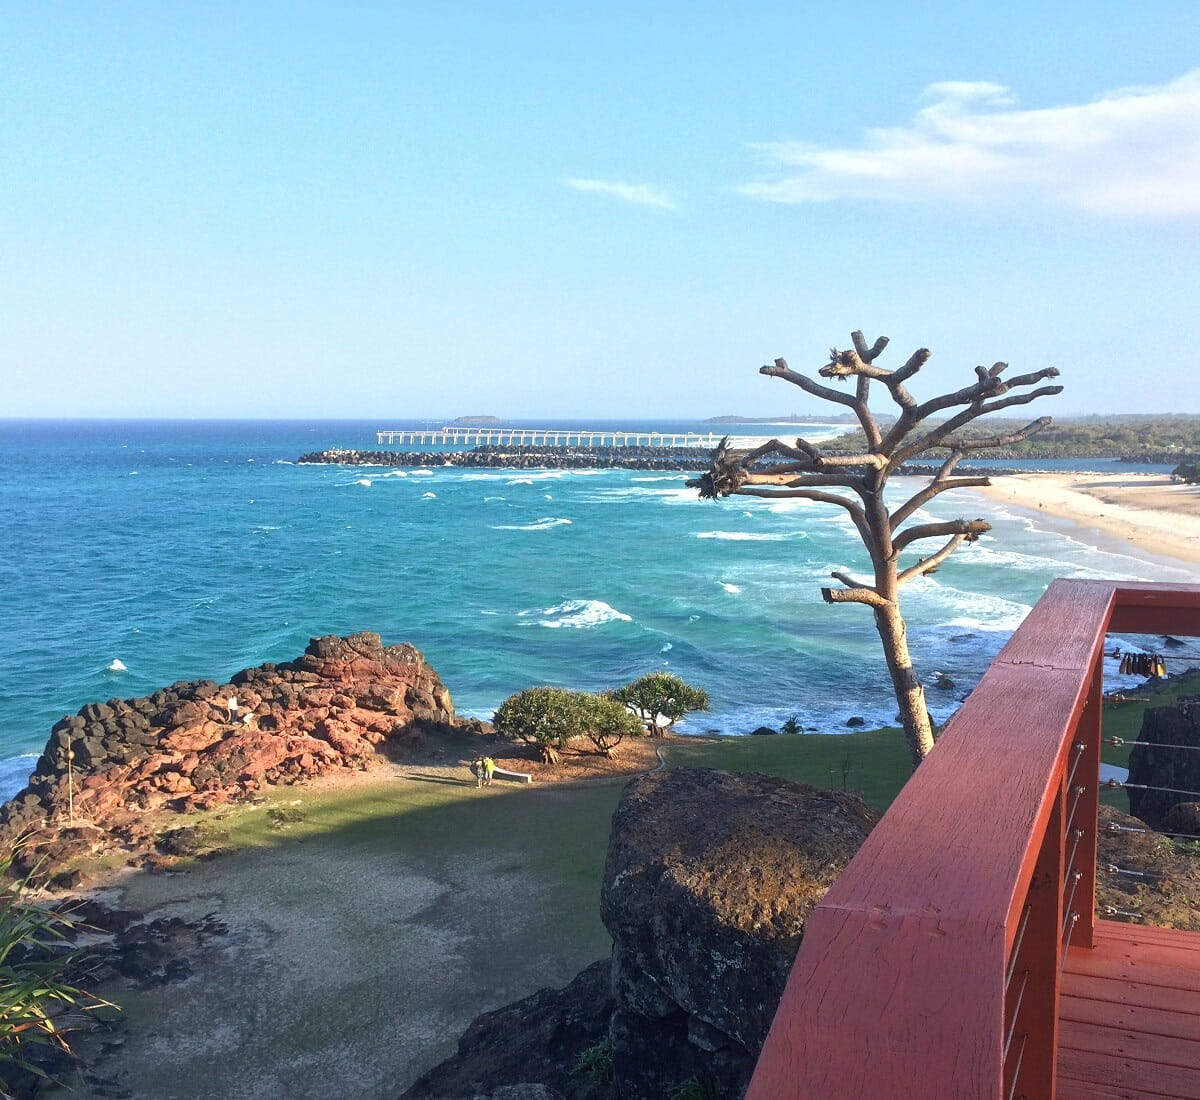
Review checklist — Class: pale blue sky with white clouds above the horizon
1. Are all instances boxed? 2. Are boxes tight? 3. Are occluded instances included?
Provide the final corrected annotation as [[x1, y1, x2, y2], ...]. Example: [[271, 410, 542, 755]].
[[0, 0, 1200, 420]]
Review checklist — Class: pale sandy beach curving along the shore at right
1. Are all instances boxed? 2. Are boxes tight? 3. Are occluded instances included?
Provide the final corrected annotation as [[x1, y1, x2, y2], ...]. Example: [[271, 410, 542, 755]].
[[979, 474, 1200, 563]]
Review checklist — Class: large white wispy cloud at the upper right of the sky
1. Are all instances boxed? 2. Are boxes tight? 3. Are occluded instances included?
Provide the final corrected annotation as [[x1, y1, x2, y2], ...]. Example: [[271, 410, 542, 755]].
[[738, 68, 1200, 217]]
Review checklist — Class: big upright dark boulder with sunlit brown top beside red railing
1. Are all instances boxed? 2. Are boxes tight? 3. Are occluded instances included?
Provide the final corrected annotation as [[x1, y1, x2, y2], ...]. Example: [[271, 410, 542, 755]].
[[600, 769, 876, 1100]]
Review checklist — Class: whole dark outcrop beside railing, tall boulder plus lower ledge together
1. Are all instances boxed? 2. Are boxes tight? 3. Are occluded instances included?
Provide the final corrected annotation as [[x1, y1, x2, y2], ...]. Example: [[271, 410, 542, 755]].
[[401, 768, 876, 1100]]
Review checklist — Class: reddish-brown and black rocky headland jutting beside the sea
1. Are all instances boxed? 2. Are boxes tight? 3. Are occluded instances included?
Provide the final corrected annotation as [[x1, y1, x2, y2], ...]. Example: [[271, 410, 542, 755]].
[[0, 633, 468, 870]]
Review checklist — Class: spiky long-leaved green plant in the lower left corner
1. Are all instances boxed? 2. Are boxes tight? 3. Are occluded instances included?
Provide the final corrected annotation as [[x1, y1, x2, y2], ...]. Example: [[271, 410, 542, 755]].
[[0, 855, 112, 1096]]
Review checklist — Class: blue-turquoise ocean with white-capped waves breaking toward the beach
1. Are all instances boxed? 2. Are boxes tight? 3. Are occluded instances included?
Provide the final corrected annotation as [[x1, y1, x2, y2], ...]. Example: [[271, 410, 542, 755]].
[[0, 420, 1195, 797]]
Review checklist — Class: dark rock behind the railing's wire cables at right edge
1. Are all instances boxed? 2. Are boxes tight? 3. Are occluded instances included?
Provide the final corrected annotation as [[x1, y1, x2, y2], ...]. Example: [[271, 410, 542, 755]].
[[1129, 699, 1200, 831]]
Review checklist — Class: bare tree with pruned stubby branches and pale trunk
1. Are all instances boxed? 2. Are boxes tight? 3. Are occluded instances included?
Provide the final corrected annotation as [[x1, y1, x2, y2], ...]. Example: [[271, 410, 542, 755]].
[[688, 332, 1062, 769]]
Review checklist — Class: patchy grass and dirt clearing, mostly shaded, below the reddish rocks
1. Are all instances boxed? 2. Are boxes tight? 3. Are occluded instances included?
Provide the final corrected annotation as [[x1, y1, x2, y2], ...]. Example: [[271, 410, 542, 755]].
[[51, 752, 654, 1100]]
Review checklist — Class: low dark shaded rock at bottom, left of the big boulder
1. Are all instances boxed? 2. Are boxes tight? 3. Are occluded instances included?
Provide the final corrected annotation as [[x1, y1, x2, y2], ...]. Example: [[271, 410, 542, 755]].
[[400, 960, 613, 1100]]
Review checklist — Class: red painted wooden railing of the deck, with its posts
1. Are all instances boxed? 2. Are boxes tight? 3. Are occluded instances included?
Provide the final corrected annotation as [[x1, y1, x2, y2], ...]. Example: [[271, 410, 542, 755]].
[[746, 581, 1200, 1100]]
